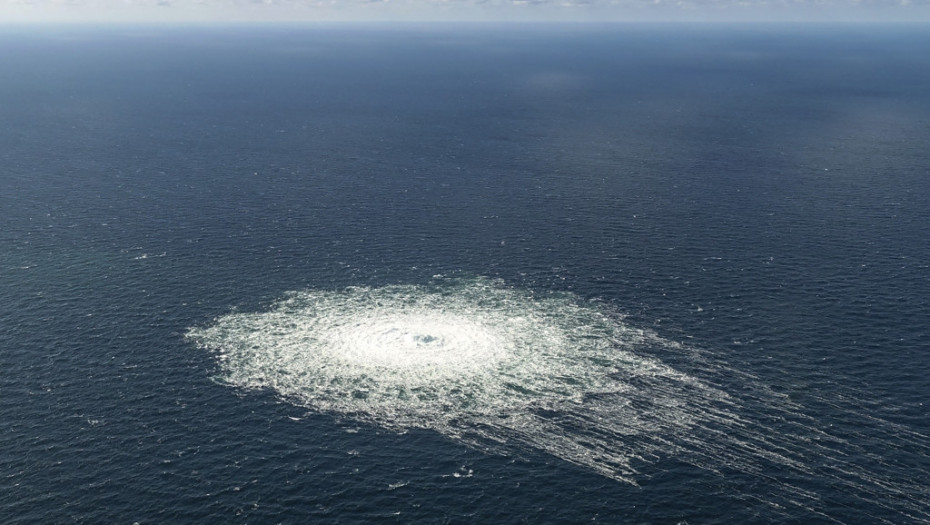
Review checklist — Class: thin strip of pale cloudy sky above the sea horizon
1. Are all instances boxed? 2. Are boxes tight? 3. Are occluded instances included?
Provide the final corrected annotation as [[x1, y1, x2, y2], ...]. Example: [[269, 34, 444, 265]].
[[0, 0, 930, 23]]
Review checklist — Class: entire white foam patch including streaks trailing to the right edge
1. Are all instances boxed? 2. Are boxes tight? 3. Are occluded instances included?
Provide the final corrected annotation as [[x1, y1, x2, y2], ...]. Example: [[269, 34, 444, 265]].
[[188, 279, 930, 523]]
